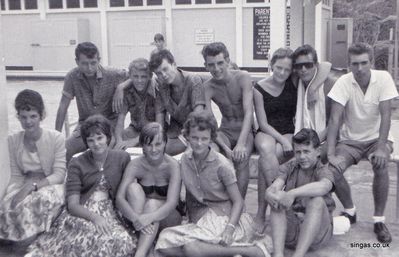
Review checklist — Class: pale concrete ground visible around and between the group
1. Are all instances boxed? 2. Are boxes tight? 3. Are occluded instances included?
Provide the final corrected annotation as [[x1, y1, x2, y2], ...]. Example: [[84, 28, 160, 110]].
[[0, 81, 399, 257]]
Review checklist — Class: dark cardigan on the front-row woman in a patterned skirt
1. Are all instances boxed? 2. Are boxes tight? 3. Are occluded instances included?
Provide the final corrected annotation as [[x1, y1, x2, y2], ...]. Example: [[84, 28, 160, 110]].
[[66, 150, 130, 204]]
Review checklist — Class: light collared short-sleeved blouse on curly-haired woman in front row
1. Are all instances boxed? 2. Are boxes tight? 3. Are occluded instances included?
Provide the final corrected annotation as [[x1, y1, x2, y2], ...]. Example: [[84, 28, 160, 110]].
[[180, 149, 237, 218]]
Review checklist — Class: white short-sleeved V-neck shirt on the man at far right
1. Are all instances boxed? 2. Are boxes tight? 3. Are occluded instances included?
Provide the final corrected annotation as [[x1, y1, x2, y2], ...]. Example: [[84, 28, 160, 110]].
[[328, 70, 398, 141]]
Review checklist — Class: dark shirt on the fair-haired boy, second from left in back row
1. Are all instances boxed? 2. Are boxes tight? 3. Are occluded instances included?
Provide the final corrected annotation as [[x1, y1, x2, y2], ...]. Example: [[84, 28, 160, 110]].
[[123, 77, 157, 132]]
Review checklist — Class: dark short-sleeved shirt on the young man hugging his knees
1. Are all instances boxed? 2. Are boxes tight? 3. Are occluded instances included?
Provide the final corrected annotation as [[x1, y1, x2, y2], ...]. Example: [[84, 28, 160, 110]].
[[278, 159, 335, 213]]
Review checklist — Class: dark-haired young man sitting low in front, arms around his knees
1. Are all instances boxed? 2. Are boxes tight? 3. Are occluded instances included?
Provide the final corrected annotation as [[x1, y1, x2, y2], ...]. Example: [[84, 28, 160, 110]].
[[266, 129, 335, 257]]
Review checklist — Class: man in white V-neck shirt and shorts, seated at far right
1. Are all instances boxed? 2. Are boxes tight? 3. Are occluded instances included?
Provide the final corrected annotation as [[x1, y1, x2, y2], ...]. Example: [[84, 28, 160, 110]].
[[327, 43, 398, 243]]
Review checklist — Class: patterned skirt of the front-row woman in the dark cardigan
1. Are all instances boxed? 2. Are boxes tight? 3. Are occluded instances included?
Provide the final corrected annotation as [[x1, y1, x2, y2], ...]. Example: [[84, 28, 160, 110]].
[[25, 176, 137, 257]]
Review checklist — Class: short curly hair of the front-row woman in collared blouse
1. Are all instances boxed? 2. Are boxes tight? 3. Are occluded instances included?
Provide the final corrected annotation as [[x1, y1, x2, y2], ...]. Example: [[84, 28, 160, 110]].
[[182, 110, 218, 141]]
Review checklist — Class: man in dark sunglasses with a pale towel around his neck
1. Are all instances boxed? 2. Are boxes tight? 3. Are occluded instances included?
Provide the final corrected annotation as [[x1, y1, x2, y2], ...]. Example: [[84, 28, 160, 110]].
[[293, 45, 343, 147]]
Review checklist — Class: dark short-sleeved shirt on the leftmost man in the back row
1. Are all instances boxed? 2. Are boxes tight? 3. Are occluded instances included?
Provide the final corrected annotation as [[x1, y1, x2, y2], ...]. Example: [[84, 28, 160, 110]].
[[62, 66, 128, 122]]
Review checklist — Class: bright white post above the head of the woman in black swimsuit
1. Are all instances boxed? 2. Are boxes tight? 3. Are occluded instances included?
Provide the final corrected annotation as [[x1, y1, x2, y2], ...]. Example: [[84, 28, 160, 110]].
[[269, 1, 293, 55]]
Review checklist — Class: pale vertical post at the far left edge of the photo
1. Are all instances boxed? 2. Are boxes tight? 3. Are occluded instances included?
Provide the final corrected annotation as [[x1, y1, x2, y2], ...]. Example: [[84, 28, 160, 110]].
[[0, 14, 10, 200]]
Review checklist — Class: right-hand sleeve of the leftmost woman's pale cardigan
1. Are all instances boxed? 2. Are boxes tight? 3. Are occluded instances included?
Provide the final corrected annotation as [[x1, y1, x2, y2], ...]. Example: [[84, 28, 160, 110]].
[[47, 133, 66, 185]]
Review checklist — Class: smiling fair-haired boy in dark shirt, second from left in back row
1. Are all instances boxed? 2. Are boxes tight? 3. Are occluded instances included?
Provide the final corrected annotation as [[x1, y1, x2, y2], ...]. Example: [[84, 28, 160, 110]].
[[114, 58, 161, 149]]
